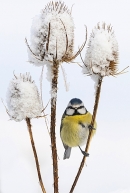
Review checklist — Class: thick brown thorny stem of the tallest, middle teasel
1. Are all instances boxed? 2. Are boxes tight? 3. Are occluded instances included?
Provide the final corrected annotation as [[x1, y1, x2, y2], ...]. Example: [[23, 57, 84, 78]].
[[50, 60, 59, 193]]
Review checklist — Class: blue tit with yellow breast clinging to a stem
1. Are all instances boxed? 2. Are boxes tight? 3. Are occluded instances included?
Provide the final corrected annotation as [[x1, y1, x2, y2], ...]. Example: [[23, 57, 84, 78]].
[[60, 98, 97, 159]]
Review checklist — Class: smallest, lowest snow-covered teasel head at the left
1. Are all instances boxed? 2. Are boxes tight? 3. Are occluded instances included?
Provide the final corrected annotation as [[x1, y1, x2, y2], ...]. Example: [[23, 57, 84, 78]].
[[7, 73, 42, 121]]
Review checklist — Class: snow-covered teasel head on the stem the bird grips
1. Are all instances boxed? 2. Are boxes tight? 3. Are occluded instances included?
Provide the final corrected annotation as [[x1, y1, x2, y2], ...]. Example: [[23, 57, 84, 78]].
[[83, 23, 118, 77]]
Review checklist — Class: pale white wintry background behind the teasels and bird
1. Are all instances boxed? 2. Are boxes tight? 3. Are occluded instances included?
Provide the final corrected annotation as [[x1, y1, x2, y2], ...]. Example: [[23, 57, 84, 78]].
[[0, 0, 130, 193]]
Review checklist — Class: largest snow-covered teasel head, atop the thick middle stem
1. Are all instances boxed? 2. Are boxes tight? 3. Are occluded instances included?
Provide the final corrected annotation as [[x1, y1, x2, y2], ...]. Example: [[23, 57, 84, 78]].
[[26, 1, 74, 66]]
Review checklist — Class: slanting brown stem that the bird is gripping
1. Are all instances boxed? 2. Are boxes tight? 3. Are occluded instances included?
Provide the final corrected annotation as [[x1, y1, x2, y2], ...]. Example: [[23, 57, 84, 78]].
[[70, 77, 102, 193]]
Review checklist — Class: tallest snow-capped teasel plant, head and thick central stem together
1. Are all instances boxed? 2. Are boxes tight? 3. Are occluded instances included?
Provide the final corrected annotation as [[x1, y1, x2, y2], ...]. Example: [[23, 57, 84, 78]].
[[26, 1, 87, 193]]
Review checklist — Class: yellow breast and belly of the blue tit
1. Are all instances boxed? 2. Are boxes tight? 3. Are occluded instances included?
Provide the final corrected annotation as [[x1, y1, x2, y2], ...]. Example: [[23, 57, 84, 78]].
[[61, 112, 96, 147]]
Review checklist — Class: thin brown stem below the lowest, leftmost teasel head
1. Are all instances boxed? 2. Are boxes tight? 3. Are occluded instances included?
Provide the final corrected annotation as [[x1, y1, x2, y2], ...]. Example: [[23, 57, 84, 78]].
[[26, 118, 46, 193]]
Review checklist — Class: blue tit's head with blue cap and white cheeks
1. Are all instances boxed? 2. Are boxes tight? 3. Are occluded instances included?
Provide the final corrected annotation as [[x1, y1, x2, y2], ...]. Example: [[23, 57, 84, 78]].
[[66, 98, 87, 116]]
